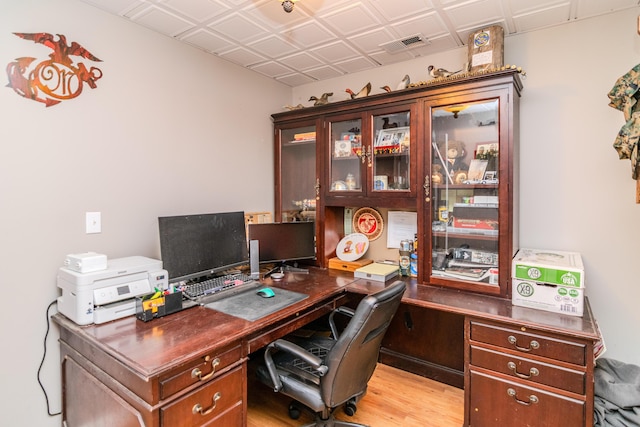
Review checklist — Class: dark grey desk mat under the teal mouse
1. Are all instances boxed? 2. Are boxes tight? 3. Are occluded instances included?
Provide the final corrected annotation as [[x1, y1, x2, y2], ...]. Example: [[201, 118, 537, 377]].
[[205, 286, 308, 322]]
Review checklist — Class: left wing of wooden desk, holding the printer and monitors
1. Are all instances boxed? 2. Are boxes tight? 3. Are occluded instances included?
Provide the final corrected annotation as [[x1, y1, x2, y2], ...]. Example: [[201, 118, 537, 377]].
[[53, 271, 353, 427]]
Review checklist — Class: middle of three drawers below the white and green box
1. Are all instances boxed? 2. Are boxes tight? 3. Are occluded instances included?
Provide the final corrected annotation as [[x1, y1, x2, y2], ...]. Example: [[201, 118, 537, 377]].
[[469, 346, 586, 394]]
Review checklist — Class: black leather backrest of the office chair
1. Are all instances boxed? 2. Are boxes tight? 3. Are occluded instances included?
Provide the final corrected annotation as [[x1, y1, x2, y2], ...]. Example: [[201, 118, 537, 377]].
[[320, 281, 406, 408]]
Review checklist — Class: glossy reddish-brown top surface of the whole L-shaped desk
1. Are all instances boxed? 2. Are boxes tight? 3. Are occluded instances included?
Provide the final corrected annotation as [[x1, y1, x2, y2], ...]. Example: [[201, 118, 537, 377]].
[[54, 269, 598, 377]]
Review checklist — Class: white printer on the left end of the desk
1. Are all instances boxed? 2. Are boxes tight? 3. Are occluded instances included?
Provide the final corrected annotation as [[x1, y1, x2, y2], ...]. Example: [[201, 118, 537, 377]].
[[57, 256, 169, 325]]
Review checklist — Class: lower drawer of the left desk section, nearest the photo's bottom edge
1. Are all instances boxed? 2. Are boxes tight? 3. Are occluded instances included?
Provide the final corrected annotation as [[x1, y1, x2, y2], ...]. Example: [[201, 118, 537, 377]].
[[160, 365, 246, 427]]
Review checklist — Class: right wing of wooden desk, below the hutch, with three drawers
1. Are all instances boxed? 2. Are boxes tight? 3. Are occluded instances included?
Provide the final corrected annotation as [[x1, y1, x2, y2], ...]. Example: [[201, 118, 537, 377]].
[[348, 280, 599, 427]]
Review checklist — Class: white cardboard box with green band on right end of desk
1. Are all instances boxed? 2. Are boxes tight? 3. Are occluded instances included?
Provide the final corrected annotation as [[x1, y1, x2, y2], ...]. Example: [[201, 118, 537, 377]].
[[511, 249, 585, 316]]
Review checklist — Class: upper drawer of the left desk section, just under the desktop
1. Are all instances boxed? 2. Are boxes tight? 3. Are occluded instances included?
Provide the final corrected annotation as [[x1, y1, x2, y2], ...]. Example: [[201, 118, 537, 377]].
[[160, 346, 242, 399]]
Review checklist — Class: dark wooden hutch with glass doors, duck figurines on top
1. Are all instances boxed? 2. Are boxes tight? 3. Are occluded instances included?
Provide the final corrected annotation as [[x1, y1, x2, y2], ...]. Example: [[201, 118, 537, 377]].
[[272, 70, 522, 297]]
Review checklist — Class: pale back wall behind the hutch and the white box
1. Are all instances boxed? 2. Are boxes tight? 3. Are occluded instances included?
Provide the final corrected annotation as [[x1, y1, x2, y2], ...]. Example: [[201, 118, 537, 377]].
[[292, 9, 640, 365]]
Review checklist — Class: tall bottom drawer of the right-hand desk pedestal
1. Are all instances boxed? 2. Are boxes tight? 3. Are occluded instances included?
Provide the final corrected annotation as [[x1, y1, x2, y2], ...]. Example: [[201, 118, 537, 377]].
[[468, 370, 586, 427]]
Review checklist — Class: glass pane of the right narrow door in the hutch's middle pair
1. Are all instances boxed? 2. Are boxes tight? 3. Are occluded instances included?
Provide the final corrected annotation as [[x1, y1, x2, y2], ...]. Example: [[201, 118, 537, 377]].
[[368, 111, 411, 192]]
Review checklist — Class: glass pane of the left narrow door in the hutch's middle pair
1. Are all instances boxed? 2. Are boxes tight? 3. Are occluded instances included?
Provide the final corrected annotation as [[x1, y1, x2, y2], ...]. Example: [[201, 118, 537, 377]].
[[329, 118, 366, 193]]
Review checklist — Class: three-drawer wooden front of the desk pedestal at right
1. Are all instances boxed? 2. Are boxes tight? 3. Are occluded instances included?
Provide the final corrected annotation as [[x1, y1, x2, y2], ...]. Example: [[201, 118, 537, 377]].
[[465, 317, 593, 427]]
